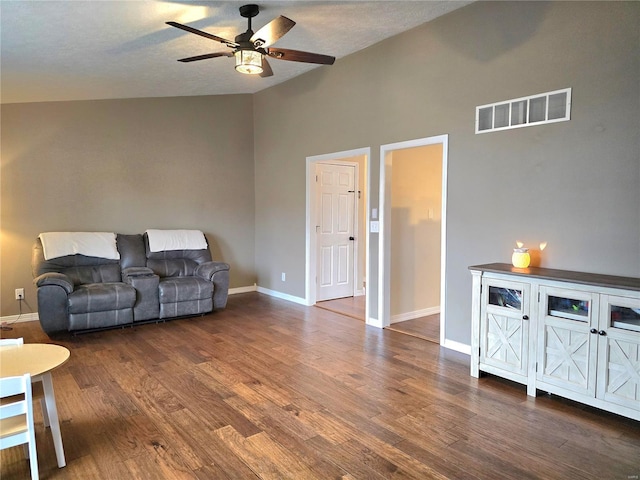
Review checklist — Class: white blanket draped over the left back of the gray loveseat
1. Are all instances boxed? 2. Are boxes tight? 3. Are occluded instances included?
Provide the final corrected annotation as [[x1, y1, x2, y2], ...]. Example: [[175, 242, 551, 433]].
[[39, 232, 120, 260]]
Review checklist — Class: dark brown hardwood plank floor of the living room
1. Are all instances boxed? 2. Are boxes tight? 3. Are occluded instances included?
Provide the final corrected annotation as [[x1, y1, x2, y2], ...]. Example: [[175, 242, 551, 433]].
[[0, 293, 640, 480]]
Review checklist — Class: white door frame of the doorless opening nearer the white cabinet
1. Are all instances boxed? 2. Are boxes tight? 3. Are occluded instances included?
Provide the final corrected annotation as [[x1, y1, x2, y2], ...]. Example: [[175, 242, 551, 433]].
[[376, 134, 449, 346]]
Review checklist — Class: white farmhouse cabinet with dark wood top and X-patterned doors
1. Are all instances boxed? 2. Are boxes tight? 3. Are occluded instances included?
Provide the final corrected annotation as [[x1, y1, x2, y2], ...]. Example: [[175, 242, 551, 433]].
[[469, 263, 640, 420]]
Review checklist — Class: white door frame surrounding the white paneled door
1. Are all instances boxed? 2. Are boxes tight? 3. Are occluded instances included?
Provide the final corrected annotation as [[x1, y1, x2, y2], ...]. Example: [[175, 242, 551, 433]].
[[305, 147, 371, 320]]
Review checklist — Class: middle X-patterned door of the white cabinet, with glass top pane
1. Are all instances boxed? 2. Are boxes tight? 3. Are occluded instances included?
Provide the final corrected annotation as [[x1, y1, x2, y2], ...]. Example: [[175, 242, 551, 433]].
[[537, 286, 598, 396]]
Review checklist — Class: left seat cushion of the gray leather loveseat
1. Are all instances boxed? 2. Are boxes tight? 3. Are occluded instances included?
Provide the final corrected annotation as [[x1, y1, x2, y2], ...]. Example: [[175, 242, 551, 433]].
[[69, 282, 136, 314]]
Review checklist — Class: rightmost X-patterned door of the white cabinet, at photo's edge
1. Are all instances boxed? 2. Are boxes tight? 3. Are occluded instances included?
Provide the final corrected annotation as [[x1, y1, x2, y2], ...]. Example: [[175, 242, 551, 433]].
[[598, 294, 640, 410]]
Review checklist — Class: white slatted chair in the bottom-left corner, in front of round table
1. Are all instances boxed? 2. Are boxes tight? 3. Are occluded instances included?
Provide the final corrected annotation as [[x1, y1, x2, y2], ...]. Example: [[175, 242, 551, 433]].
[[0, 373, 39, 480]]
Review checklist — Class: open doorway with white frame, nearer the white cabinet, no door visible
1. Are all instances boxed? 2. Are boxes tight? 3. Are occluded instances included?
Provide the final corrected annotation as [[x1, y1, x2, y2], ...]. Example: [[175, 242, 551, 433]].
[[378, 135, 448, 344]]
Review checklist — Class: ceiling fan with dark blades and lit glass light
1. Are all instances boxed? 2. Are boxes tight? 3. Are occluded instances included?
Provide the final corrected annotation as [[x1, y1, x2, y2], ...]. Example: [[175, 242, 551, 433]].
[[167, 4, 335, 77]]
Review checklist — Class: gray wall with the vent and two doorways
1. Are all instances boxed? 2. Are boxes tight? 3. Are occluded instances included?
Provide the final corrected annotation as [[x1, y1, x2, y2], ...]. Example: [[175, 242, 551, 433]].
[[254, 2, 640, 345]]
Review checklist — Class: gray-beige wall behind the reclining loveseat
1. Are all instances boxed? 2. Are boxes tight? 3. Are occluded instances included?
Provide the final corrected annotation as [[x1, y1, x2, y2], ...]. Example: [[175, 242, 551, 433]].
[[0, 95, 256, 316]]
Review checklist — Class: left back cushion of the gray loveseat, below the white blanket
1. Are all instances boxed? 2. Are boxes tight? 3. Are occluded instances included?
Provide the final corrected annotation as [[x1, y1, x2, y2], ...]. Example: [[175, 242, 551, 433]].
[[31, 238, 122, 285]]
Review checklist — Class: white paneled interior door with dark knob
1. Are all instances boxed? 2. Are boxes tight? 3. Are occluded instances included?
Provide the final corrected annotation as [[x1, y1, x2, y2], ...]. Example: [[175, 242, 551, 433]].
[[316, 163, 356, 301]]
